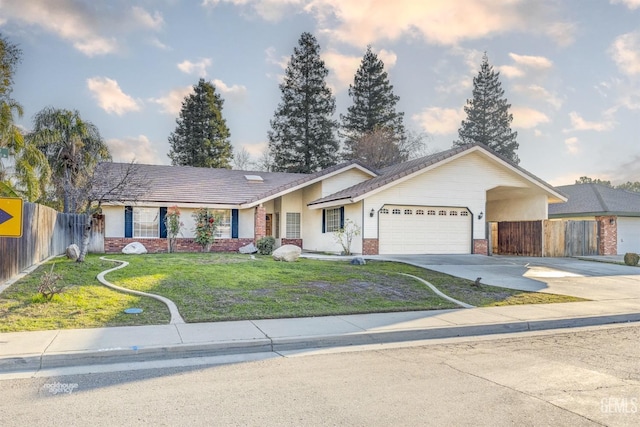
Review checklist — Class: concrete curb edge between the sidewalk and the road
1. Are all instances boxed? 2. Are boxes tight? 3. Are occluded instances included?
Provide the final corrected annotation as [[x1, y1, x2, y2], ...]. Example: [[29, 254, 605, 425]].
[[0, 313, 640, 373]]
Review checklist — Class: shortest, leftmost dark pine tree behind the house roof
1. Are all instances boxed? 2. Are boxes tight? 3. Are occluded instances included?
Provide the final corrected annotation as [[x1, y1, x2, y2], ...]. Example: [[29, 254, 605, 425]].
[[169, 79, 233, 169]]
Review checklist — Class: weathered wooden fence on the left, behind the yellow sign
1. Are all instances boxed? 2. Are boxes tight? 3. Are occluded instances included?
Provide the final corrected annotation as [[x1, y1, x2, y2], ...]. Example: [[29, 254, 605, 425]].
[[0, 203, 86, 283]]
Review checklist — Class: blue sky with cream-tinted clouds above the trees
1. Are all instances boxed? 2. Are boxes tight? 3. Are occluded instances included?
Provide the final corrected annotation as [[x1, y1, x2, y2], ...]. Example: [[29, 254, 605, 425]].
[[0, 0, 640, 185]]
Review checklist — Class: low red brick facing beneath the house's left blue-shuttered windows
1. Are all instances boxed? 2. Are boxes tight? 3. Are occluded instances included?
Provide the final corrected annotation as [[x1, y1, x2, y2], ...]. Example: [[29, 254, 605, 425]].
[[104, 237, 253, 254]]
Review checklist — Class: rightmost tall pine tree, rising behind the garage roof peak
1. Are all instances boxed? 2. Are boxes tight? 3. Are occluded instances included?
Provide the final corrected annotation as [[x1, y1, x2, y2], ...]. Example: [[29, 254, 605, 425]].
[[453, 53, 520, 164]]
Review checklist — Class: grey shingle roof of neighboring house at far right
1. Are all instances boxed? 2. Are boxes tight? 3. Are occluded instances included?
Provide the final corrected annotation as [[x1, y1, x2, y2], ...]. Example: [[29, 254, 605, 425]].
[[549, 184, 640, 217]]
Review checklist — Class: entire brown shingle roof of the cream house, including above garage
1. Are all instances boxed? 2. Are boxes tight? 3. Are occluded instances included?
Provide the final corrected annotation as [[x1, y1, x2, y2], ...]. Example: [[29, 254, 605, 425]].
[[94, 144, 562, 206]]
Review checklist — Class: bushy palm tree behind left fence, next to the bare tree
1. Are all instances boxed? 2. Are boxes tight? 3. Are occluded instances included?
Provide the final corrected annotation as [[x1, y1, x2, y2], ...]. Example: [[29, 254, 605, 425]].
[[27, 107, 111, 213]]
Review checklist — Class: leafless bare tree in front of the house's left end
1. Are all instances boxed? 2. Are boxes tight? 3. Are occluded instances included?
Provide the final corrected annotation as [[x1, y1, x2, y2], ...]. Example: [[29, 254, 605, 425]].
[[77, 161, 151, 262]]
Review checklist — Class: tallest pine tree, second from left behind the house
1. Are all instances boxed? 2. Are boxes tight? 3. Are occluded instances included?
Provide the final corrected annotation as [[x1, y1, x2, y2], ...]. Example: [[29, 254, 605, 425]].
[[268, 32, 339, 173]]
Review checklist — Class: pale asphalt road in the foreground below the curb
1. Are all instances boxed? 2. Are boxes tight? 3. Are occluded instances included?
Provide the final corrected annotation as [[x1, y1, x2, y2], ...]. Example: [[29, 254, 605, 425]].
[[0, 324, 640, 426]]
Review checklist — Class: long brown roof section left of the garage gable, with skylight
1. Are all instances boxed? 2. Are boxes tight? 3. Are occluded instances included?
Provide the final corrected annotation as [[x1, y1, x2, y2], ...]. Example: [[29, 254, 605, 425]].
[[94, 161, 375, 206]]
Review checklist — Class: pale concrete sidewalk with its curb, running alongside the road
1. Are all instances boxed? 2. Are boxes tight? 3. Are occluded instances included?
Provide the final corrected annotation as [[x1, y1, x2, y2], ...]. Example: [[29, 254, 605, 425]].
[[0, 299, 640, 373]]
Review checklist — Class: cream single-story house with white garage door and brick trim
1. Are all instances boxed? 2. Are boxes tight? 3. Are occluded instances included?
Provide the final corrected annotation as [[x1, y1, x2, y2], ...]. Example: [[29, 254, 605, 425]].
[[96, 145, 566, 255]]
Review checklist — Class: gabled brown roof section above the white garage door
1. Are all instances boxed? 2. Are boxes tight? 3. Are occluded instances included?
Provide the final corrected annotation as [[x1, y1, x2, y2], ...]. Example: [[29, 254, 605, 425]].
[[310, 144, 564, 204]]
